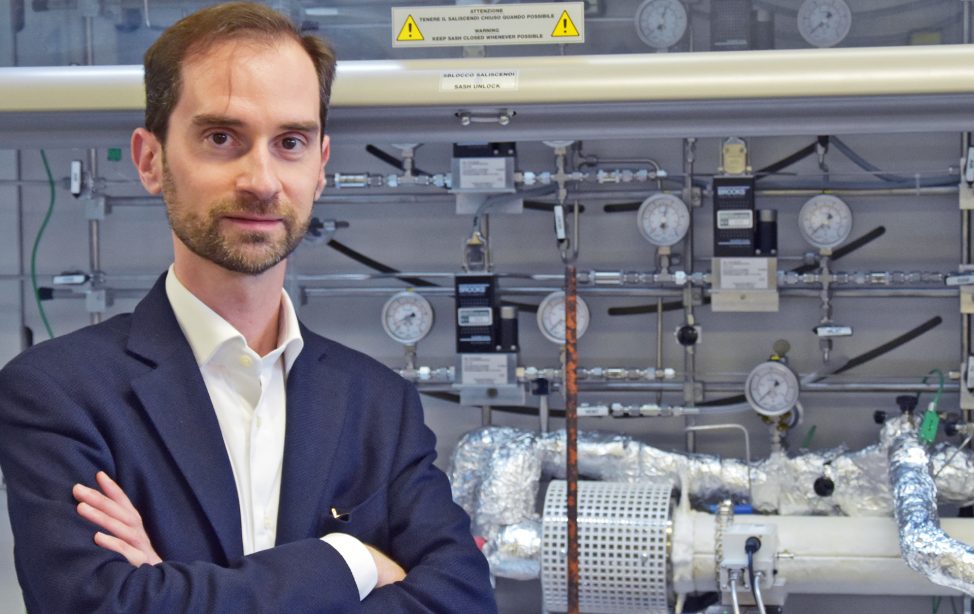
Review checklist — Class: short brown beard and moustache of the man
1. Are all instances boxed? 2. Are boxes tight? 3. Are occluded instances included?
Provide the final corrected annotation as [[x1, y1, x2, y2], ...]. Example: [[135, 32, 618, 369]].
[[162, 157, 311, 275]]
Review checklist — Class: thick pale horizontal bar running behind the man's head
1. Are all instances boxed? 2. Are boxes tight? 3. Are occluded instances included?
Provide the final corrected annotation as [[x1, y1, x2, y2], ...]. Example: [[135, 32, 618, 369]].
[[9, 45, 974, 112]]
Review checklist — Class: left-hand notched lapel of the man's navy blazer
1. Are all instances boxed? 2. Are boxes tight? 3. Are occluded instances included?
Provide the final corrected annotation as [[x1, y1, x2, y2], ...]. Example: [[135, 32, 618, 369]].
[[128, 275, 243, 561]]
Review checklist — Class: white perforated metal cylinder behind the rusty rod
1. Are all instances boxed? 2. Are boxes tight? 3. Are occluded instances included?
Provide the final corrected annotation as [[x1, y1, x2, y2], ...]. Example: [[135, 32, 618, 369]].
[[541, 480, 672, 614]]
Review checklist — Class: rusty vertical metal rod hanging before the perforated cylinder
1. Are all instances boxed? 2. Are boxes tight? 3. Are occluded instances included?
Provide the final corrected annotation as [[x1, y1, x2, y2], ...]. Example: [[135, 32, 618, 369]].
[[565, 264, 579, 614]]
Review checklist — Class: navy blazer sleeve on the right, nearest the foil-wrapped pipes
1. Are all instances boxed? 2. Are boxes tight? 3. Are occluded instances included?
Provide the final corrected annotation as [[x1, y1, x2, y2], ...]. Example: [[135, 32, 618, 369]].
[[362, 384, 497, 614]]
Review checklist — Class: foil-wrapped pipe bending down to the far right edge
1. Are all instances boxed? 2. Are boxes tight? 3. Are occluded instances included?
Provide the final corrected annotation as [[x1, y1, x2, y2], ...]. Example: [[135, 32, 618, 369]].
[[889, 433, 974, 595]]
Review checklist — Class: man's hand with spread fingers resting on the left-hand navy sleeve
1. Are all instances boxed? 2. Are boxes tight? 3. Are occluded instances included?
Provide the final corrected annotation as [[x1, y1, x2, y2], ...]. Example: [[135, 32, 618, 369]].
[[71, 471, 162, 577]]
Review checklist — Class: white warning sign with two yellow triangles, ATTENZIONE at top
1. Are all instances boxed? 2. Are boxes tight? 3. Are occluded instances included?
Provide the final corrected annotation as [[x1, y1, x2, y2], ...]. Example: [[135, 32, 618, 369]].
[[392, 2, 585, 47]]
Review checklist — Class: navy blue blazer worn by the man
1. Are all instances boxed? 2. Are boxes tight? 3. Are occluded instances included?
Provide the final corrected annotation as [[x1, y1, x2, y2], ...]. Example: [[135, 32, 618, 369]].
[[0, 276, 496, 614]]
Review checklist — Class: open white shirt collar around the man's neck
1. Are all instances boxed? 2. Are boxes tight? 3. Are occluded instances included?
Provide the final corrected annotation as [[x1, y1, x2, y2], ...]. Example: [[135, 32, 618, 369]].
[[166, 266, 304, 373]]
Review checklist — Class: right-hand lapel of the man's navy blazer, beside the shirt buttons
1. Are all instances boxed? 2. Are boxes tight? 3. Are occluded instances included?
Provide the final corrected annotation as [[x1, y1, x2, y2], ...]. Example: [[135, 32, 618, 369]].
[[277, 326, 351, 544]]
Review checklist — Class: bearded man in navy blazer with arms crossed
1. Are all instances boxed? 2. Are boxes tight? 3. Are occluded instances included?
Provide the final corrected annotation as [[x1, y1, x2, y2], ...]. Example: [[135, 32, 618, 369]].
[[0, 4, 496, 614]]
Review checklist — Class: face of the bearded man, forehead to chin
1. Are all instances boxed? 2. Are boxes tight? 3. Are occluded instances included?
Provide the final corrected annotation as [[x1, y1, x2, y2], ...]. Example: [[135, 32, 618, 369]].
[[135, 40, 328, 275]]
